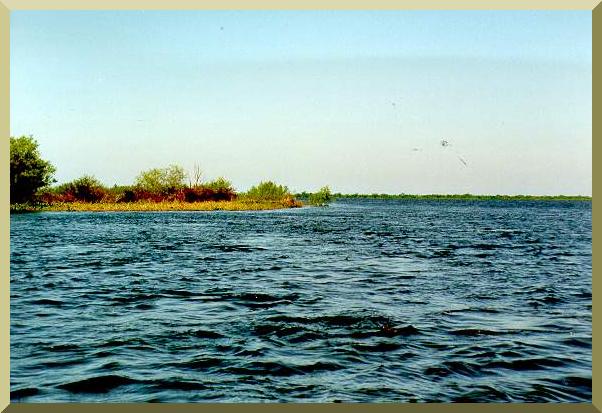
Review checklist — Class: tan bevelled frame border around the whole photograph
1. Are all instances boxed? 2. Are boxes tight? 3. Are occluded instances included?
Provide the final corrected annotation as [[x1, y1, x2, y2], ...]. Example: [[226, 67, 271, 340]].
[[0, 0, 602, 413]]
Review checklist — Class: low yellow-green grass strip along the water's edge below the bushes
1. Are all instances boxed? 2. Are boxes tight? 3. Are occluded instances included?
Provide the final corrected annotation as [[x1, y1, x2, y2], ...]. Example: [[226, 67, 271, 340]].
[[35, 200, 303, 212]]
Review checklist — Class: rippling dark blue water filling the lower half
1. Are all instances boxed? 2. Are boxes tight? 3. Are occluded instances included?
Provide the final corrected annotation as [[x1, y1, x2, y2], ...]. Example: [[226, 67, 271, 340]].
[[10, 200, 592, 402]]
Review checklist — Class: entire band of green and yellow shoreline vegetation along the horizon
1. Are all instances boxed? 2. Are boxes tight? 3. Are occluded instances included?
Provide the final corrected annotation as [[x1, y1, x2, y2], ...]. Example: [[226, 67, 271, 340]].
[[10, 136, 591, 212]]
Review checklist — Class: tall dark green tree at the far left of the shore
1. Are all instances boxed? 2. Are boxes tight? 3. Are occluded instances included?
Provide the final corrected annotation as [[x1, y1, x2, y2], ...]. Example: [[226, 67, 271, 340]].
[[10, 136, 56, 203]]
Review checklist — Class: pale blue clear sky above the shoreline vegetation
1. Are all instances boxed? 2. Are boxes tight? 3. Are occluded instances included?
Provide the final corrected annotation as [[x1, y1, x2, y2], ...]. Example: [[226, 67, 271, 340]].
[[10, 11, 592, 195]]
